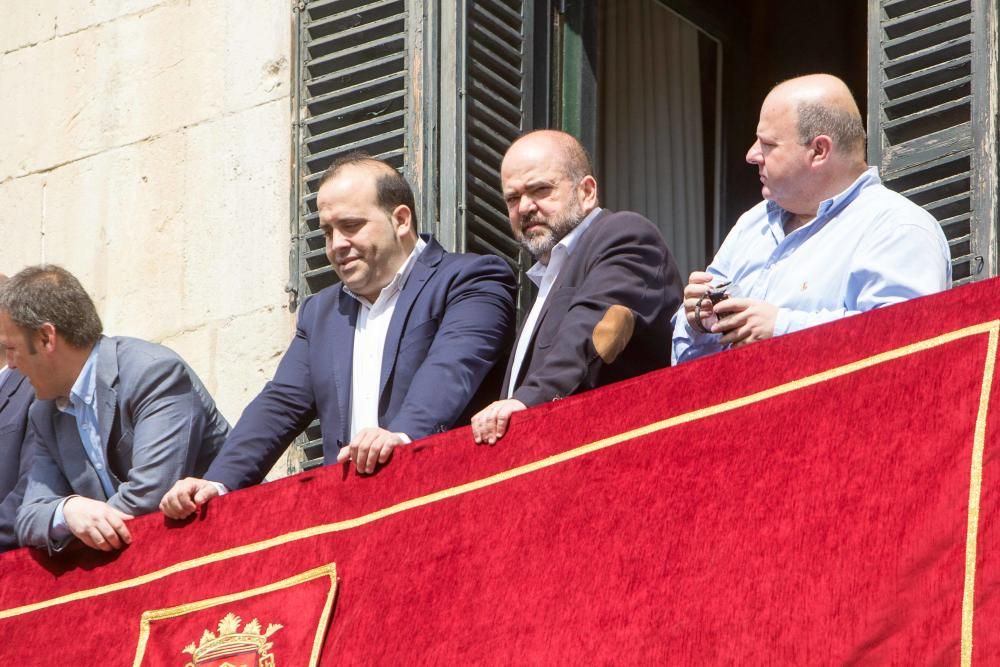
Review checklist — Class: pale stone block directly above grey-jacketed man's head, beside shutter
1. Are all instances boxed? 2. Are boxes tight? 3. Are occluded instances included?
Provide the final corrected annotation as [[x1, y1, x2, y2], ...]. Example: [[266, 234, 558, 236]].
[[38, 101, 290, 339]]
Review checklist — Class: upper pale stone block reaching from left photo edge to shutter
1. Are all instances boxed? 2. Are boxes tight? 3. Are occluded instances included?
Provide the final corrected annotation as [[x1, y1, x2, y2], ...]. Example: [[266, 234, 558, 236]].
[[0, 0, 291, 180]]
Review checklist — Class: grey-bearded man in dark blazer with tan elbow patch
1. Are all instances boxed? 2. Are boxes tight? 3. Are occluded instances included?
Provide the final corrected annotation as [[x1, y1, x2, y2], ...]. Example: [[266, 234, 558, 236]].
[[472, 130, 682, 444]]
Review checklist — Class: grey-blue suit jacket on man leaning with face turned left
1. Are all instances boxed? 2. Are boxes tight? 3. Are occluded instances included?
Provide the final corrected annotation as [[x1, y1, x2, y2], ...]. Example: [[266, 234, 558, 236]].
[[16, 338, 229, 551]]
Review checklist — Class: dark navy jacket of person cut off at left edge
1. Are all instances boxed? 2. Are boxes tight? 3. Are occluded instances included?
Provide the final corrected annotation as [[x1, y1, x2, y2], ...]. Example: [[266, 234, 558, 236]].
[[0, 370, 35, 551]]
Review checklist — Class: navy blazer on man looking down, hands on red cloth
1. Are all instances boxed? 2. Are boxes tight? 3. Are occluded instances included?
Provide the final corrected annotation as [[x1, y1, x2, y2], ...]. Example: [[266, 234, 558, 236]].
[[205, 236, 515, 489]]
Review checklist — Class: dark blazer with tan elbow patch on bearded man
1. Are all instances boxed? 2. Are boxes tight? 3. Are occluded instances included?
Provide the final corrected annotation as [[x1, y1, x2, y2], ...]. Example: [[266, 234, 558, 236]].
[[501, 209, 683, 407]]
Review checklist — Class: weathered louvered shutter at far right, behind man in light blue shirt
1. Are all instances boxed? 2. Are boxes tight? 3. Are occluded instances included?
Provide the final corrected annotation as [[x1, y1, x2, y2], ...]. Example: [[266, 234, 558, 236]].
[[868, 0, 997, 284]]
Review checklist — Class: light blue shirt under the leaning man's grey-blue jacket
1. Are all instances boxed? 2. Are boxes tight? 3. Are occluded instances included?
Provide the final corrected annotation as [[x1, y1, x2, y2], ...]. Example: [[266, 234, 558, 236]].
[[50, 341, 115, 540]]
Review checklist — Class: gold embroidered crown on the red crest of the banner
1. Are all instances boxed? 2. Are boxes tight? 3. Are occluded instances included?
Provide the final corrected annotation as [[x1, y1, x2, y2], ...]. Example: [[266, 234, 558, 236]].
[[183, 613, 284, 667]]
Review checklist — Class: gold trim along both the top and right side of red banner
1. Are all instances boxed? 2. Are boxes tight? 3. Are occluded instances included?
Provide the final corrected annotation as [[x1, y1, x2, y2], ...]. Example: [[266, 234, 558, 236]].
[[0, 320, 1000, 667]]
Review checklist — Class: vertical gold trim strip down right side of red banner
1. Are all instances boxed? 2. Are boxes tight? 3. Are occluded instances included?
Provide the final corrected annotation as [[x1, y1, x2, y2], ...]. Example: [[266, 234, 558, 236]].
[[962, 328, 1000, 667]]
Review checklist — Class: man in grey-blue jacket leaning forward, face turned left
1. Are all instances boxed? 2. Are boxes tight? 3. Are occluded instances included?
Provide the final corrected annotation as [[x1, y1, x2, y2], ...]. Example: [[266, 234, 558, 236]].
[[0, 266, 229, 552]]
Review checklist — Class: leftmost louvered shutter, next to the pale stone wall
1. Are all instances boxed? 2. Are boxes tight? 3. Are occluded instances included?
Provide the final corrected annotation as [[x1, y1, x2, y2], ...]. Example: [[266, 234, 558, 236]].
[[294, 0, 412, 306]]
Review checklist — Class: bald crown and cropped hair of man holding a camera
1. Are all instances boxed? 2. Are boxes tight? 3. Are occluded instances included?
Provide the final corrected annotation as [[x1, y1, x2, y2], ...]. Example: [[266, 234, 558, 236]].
[[764, 74, 865, 161]]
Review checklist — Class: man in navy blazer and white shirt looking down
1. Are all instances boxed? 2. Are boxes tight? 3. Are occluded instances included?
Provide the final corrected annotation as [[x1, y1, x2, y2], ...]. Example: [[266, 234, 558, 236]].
[[160, 155, 515, 518]]
